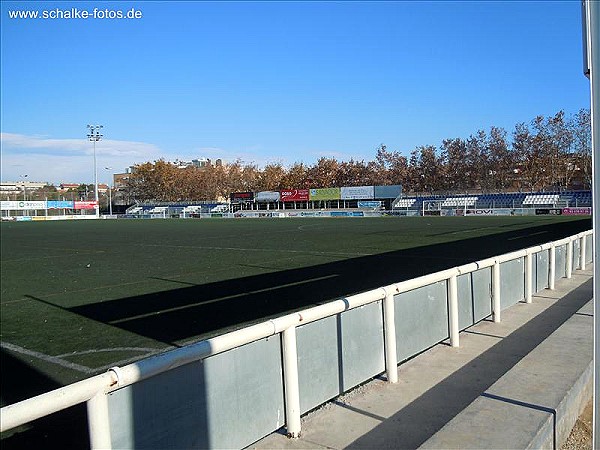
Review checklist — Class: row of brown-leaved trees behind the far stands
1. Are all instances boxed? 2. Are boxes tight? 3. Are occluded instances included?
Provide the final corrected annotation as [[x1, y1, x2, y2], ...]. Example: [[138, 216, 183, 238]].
[[122, 109, 592, 201]]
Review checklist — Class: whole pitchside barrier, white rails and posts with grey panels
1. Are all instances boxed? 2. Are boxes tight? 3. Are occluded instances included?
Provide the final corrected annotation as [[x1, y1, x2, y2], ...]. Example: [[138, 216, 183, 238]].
[[0, 231, 592, 449]]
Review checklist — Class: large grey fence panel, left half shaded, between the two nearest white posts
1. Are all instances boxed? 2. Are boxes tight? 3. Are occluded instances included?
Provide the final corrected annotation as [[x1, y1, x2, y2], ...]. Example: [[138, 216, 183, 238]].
[[108, 336, 285, 449]]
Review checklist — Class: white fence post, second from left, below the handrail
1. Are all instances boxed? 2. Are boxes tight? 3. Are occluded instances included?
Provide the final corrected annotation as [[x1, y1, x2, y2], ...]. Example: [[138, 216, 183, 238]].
[[282, 326, 300, 438]]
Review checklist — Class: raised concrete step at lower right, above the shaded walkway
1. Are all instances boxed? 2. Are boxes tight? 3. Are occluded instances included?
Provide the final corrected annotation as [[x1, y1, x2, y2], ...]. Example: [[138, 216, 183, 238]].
[[420, 301, 594, 449]]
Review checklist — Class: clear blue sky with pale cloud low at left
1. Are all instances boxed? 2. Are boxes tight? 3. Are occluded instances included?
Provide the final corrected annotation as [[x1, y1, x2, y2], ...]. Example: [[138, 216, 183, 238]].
[[0, 0, 589, 183]]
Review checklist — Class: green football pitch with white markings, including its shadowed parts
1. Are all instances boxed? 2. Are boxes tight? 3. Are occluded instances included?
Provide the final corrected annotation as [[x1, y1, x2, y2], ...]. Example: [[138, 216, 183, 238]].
[[0, 216, 591, 405]]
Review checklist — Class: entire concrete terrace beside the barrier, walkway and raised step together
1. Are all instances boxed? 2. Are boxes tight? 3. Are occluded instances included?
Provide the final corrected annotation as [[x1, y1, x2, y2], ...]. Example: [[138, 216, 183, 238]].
[[249, 265, 593, 449]]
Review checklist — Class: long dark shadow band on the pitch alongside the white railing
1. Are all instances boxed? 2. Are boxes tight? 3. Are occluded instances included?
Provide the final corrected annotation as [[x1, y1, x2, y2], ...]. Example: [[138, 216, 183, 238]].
[[68, 219, 591, 345]]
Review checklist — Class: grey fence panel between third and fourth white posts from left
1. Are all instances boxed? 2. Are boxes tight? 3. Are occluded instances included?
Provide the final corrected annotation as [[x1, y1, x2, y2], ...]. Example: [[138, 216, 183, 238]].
[[394, 281, 449, 361]]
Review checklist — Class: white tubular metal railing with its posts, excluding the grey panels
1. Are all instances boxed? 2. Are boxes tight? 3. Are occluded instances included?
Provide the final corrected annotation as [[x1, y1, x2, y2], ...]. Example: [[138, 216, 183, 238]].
[[0, 231, 592, 449]]
